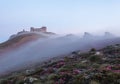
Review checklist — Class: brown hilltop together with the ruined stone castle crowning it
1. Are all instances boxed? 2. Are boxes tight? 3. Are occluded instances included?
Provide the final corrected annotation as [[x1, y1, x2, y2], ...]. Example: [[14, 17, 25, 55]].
[[0, 27, 55, 54]]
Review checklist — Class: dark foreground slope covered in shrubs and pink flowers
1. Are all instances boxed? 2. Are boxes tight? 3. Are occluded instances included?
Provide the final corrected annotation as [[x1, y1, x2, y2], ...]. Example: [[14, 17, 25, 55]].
[[0, 44, 120, 84]]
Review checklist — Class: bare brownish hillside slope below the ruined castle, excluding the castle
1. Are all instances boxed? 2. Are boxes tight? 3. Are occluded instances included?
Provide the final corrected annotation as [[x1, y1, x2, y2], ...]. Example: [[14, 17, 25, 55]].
[[0, 33, 49, 54]]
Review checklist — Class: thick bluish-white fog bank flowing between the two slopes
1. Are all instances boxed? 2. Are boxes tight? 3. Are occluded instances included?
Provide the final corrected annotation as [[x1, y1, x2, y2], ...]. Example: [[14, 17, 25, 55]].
[[0, 35, 117, 74]]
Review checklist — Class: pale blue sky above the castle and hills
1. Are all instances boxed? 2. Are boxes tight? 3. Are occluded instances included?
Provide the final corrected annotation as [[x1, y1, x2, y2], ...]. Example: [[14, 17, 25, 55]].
[[0, 0, 120, 42]]
